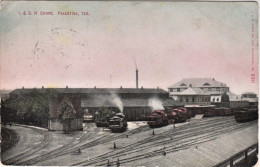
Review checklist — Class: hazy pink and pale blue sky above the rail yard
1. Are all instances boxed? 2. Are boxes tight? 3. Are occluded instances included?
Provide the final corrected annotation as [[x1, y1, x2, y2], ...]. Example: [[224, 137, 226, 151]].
[[0, 1, 258, 94]]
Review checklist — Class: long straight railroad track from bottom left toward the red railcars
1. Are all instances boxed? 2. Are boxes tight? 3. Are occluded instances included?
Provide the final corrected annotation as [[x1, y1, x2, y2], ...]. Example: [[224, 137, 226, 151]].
[[14, 122, 150, 165]]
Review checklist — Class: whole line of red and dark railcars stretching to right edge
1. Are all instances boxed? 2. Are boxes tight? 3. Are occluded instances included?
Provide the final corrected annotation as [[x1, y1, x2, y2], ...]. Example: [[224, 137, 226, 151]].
[[147, 105, 258, 128]]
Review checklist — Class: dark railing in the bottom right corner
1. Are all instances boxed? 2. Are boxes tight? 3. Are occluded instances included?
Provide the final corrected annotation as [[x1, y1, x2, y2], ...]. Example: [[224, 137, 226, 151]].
[[213, 143, 258, 167]]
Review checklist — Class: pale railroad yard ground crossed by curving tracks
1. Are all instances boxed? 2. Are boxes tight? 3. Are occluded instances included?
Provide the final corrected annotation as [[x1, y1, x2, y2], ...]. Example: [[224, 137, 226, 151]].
[[1, 116, 258, 167]]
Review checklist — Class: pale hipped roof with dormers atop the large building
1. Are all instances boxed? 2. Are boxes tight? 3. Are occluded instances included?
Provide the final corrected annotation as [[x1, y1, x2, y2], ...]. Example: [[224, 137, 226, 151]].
[[168, 78, 227, 88]]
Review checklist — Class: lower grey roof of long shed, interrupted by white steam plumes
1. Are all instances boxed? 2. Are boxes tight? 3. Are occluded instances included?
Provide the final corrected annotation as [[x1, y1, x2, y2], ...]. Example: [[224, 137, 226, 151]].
[[81, 98, 179, 107]]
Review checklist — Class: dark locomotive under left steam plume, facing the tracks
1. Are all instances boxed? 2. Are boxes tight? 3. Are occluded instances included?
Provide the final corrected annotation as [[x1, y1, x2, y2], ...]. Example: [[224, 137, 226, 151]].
[[109, 113, 127, 132]]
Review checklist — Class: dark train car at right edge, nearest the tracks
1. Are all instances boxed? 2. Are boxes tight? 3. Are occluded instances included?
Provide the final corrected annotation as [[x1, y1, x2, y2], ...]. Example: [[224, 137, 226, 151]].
[[235, 109, 258, 122]]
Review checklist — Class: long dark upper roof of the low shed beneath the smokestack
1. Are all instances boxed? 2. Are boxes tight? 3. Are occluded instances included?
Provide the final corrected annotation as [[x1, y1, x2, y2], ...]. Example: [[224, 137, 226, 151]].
[[10, 88, 168, 94]]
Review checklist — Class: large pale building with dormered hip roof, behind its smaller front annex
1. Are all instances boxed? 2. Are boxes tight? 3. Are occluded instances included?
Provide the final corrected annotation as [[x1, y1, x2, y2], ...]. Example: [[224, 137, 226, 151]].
[[168, 78, 229, 99]]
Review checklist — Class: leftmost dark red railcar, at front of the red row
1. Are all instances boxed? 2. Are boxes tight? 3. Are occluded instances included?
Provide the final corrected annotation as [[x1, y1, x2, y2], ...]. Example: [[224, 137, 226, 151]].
[[147, 110, 168, 128]]
